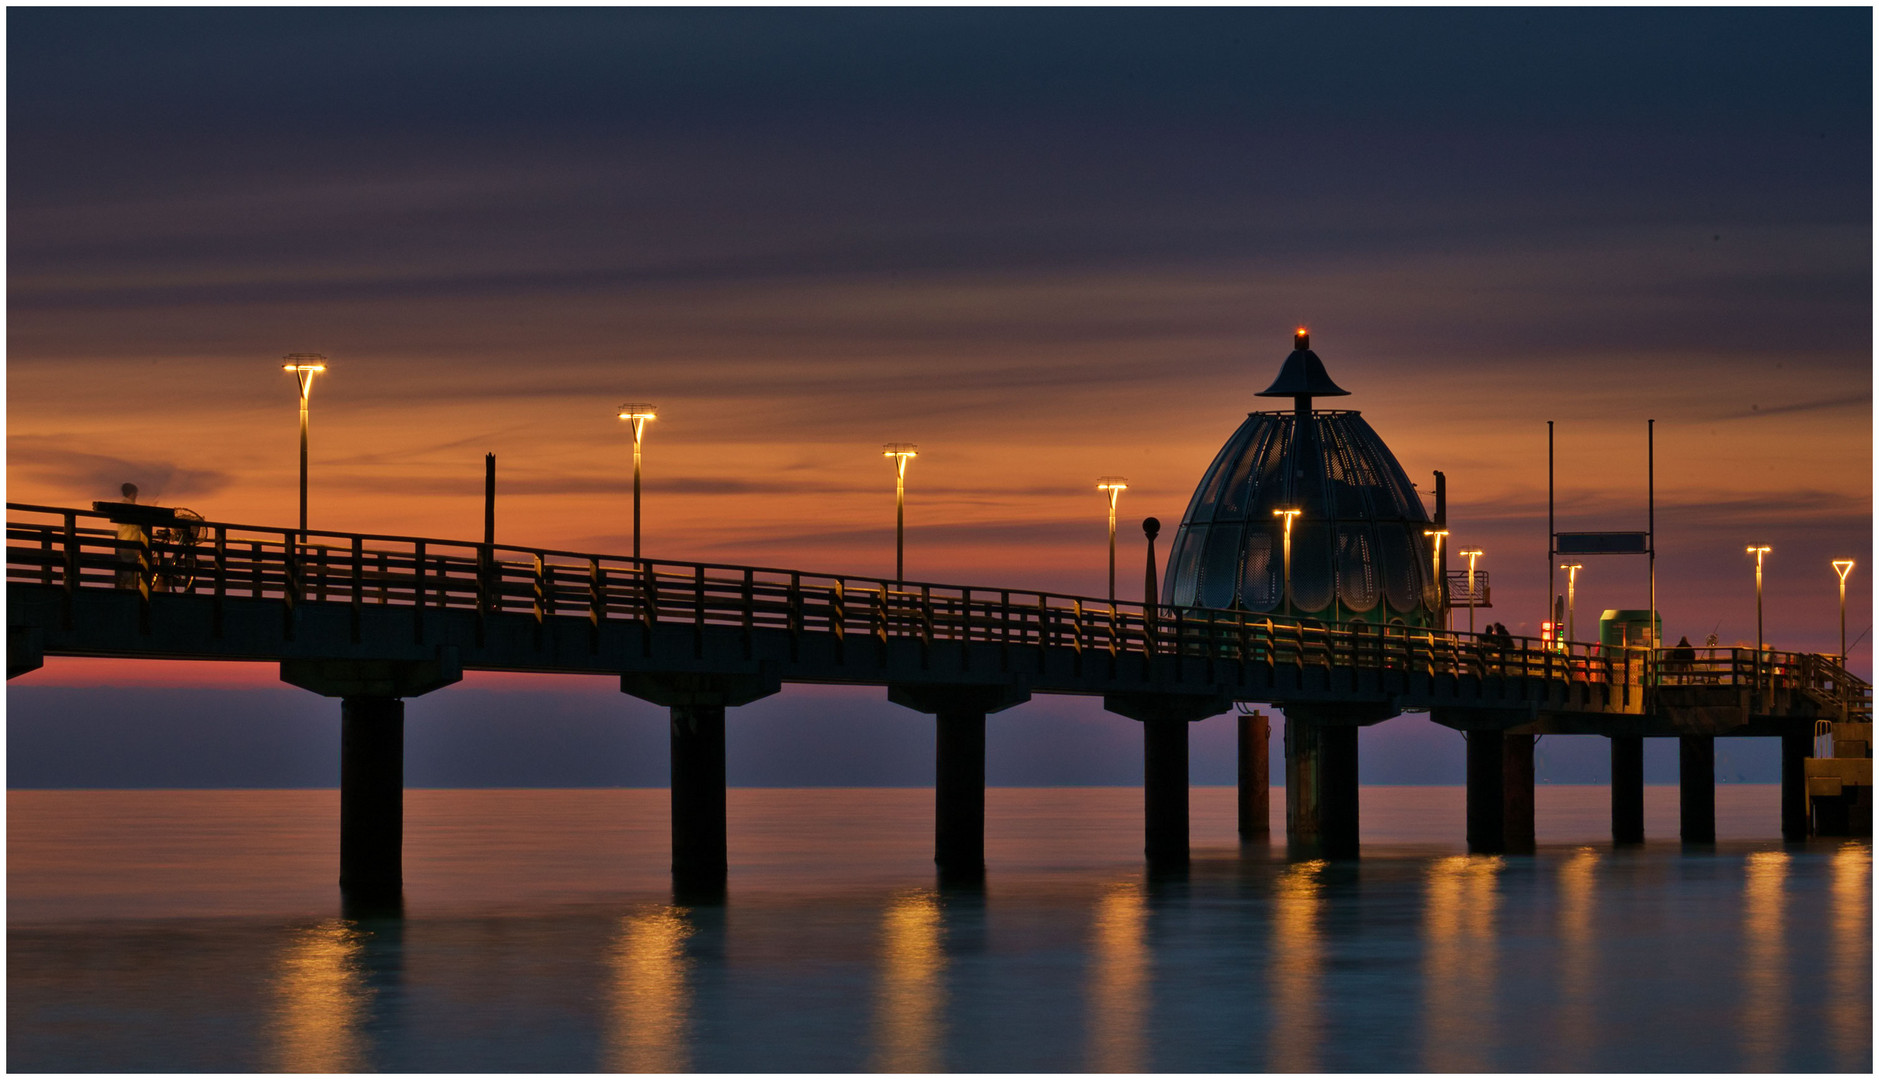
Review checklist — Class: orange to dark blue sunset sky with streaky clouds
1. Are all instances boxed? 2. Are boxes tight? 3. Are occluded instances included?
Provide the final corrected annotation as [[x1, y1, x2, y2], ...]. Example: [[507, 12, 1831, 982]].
[[6, 8, 1873, 783]]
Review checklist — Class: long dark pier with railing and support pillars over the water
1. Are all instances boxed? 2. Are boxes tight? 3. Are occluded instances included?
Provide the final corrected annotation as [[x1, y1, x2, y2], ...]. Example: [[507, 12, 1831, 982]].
[[8, 503, 1871, 894]]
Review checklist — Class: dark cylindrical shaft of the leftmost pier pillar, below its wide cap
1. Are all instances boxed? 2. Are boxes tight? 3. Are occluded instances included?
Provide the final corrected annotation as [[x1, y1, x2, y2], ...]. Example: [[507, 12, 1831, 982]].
[[340, 697, 404, 898]]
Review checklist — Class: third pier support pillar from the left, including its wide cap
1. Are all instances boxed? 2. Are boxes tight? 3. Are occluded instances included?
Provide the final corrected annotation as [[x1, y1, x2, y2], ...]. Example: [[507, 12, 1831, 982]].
[[887, 684, 1032, 883]]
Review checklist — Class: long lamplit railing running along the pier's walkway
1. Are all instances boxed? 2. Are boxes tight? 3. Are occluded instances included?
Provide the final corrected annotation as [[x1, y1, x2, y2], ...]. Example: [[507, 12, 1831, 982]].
[[8, 503, 1833, 693]]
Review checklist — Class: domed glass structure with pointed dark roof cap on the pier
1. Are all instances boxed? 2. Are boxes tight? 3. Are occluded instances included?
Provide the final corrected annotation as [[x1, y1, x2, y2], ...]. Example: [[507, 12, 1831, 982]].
[[1161, 331, 1439, 625]]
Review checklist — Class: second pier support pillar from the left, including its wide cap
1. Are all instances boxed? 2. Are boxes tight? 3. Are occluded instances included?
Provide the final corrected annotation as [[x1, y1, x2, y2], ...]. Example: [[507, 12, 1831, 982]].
[[620, 672, 782, 902]]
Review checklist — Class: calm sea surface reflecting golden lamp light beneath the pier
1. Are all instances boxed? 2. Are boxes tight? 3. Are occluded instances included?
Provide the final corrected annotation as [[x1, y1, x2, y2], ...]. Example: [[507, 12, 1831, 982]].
[[8, 785, 1873, 1072]]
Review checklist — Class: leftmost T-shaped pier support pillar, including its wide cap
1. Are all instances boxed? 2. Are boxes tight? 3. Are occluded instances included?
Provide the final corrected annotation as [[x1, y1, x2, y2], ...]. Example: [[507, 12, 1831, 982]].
[[280, 648, 462, 913]]
